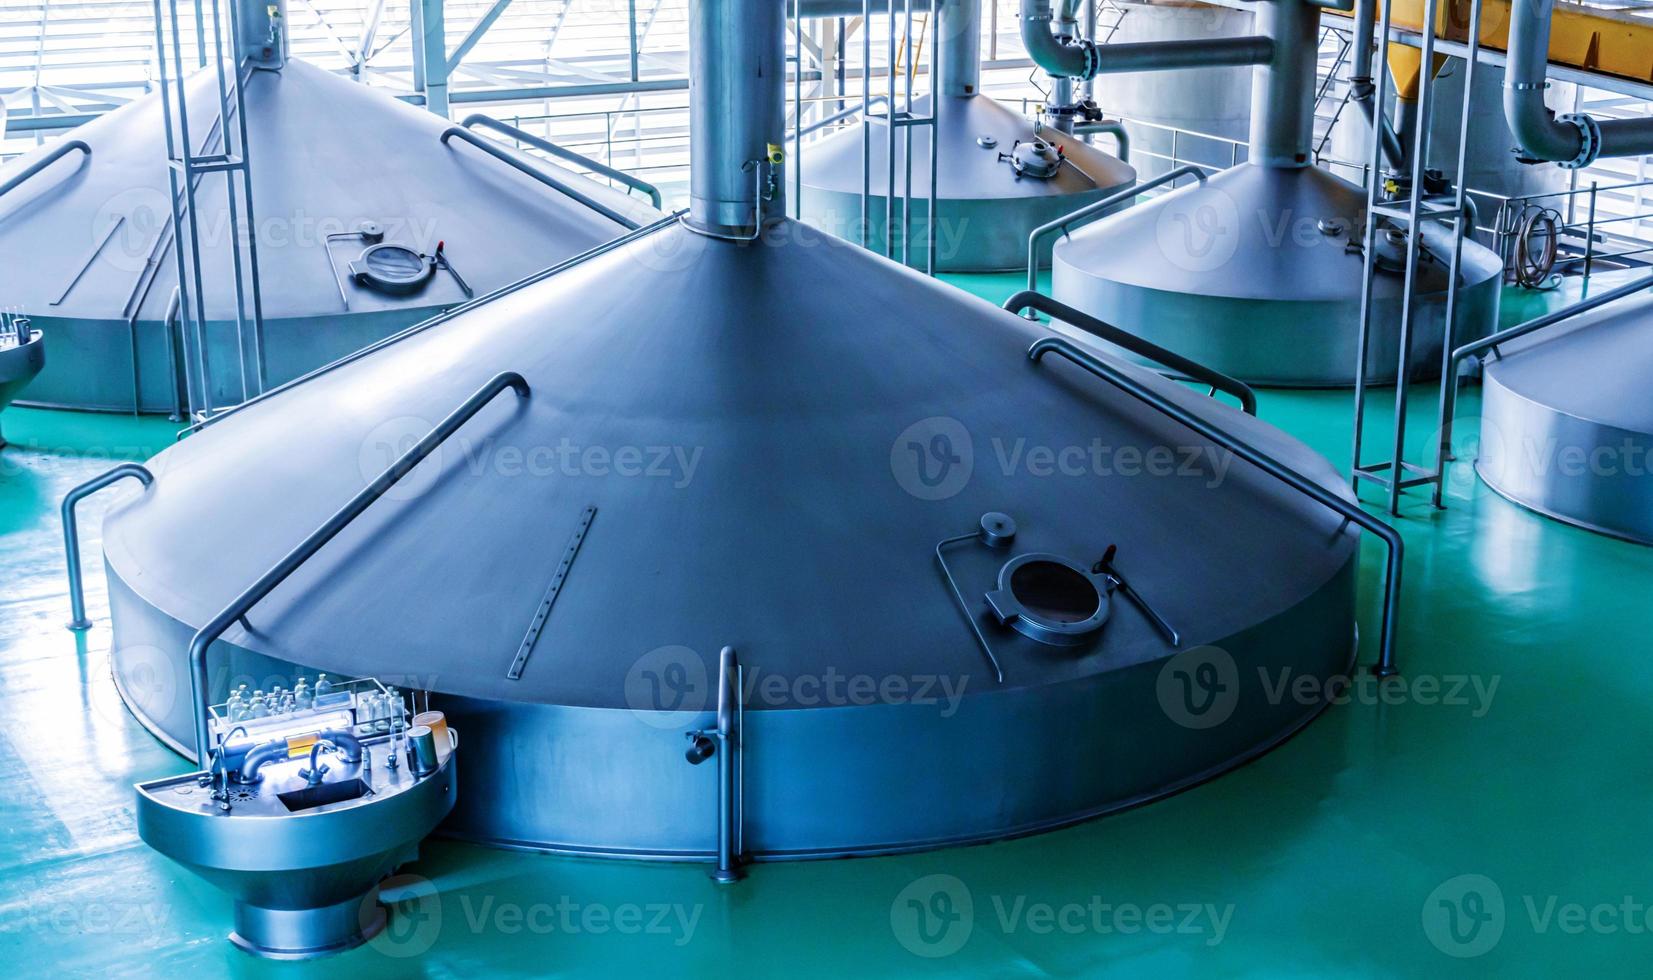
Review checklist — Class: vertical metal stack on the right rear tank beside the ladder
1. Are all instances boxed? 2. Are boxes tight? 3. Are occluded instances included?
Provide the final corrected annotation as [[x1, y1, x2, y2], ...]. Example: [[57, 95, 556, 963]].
[[1251, 0, 1315, 167]]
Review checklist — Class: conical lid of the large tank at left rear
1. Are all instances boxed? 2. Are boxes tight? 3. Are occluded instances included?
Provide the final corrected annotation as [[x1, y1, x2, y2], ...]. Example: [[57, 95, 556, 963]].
[[0, 61, 658, 321]]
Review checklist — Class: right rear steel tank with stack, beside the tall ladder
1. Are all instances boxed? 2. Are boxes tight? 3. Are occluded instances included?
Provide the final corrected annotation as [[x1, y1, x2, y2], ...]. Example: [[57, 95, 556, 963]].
[[1051, 0, 1503, 387]]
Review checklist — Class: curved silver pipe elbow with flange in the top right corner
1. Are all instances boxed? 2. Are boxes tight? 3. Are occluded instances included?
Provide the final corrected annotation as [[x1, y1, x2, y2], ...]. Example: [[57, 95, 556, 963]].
[[1504, 0, 1653, 169]]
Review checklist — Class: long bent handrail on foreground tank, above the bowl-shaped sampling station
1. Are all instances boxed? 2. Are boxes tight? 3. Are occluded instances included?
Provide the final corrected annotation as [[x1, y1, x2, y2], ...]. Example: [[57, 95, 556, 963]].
[[190, 370, 529, 765]]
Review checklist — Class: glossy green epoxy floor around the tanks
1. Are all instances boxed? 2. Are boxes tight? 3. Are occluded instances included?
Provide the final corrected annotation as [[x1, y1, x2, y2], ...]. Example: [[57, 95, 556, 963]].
[[0, 278, 1653, 977]]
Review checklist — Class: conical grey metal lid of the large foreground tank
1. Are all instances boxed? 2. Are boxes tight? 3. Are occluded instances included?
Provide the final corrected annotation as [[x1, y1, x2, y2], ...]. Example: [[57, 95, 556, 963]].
[[104, 221, 1357, 707]]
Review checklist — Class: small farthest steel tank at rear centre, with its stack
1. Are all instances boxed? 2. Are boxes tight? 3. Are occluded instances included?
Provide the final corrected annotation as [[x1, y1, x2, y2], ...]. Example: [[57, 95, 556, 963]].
[[798, 0, 1136, 273]]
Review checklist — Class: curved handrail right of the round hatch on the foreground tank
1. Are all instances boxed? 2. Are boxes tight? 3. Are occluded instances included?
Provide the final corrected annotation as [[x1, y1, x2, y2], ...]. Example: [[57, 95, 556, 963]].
[[1028, 337, 1405, 678]]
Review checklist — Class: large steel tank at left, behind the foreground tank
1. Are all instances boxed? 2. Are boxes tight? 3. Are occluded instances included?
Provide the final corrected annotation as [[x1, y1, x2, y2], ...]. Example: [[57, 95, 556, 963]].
[[0, 61, 646, 412]]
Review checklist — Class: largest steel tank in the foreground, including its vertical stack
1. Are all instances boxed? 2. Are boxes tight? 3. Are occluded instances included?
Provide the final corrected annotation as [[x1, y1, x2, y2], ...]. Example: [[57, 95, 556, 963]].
[[102, 0, 1359, 859]]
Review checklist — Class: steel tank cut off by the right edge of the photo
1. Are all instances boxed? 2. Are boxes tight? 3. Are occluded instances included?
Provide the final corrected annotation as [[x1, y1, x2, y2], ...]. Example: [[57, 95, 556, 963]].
[[1476, 285, 1653, 544]]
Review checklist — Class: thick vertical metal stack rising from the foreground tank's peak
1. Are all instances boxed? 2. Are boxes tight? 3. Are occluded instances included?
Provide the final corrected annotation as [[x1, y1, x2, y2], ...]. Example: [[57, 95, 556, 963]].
[[688, 0, 787, 238]]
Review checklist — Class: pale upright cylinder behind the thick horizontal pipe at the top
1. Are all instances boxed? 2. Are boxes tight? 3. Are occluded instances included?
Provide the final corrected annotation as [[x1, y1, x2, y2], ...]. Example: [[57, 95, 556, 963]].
[[1094, 0, 1255, 180]]
